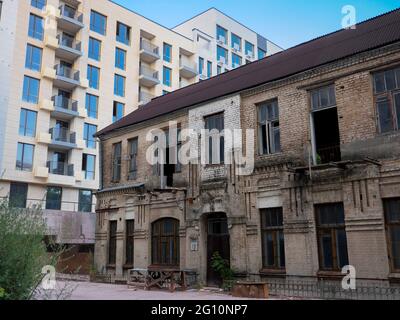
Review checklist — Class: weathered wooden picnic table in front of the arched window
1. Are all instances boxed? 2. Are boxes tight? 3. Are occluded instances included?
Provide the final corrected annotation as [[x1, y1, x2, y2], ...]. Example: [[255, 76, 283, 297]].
[[128, 266, 195, 292]]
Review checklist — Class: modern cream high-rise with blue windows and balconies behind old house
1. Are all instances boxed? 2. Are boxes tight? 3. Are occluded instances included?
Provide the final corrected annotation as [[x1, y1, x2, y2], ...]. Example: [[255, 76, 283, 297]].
[[0, 0, 282, 266]]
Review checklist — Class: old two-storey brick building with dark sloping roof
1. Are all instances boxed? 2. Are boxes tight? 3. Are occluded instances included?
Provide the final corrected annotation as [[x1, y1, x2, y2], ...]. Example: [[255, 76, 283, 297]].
[[95, 10, 400, 284]]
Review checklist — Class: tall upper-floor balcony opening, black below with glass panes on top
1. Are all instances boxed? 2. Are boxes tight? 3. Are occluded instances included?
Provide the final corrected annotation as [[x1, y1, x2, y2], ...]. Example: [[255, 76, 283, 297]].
[[311, 85, 341, 164]]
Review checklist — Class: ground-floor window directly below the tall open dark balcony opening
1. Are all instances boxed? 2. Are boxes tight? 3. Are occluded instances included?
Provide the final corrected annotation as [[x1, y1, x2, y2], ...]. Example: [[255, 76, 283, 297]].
[[315, 203, 349, 271]]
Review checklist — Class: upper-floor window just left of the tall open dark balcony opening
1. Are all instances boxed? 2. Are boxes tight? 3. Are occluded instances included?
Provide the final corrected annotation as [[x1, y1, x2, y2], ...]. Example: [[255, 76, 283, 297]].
[[258, 100, 281, 154]]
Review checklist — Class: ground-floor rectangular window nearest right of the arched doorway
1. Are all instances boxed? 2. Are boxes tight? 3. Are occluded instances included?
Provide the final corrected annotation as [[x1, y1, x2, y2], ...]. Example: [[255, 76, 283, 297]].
[[261, 208, 285, 269]]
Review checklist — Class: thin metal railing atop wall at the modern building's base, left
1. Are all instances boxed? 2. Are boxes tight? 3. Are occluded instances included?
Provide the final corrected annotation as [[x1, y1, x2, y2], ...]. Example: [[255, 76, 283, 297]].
[[0, 196, 96, 213]]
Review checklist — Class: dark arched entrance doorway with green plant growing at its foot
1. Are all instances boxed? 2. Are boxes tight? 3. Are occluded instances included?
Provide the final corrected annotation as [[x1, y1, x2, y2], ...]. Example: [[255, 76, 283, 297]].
[[206, 213, 230, 286]]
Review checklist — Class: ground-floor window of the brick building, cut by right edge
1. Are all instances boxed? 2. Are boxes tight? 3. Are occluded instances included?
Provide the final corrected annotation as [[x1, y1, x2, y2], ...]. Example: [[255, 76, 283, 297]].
[[383, 198, 400, 272]]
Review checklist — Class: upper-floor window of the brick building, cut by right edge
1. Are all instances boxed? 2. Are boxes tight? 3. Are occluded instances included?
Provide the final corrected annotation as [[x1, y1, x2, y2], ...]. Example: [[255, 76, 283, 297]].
[[373, 68, 400, 133]]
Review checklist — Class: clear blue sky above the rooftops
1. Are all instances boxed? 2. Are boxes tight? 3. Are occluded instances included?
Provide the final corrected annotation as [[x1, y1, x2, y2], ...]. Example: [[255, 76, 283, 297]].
[[114, 0, 400, 49]]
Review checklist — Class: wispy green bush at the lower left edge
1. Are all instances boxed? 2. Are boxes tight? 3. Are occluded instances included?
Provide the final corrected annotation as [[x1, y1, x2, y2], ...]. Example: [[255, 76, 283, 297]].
[[0, 201, 72, 300]]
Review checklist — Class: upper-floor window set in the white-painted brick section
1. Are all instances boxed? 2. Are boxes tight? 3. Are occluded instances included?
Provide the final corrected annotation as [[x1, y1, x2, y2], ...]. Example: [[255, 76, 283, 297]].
[[204, 112, 225, 164]]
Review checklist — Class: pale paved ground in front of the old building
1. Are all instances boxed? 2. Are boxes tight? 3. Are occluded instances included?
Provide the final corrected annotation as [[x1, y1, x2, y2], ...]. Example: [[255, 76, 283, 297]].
[[57, 281, 264, 300]]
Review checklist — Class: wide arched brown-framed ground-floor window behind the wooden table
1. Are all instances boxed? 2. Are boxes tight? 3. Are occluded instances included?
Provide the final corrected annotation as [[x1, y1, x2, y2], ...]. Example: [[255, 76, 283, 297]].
[[151, 218, 179, 266]]
